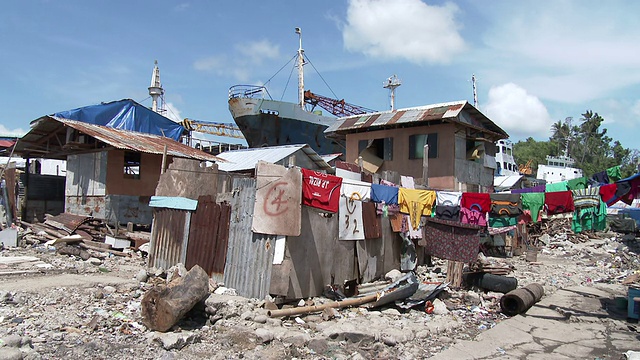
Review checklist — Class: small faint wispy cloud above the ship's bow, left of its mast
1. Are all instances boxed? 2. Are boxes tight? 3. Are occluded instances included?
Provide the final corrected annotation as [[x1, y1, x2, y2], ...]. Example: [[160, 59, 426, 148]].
[[193, 40, 280, 82]]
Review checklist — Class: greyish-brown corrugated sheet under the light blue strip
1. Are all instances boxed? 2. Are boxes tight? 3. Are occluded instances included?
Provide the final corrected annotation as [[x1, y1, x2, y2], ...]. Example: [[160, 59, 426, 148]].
[[149, 208, 191, 270]]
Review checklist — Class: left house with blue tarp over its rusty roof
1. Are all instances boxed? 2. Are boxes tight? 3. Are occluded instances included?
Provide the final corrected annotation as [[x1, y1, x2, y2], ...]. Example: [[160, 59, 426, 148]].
[[15, 100, 219, 224]]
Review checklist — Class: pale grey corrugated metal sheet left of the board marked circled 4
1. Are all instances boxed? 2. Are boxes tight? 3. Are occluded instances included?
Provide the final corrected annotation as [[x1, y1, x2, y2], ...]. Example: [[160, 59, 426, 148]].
[[223, 179, 276, 299]]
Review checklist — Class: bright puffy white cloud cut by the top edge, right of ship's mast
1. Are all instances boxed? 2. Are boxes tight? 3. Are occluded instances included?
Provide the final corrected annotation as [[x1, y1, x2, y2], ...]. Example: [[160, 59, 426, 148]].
[[342, 0, 466, 65]]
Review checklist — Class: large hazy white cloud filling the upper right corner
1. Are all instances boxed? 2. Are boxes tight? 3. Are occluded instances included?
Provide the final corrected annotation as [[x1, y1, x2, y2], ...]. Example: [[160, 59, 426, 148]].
[[472, 1, 640, 104]]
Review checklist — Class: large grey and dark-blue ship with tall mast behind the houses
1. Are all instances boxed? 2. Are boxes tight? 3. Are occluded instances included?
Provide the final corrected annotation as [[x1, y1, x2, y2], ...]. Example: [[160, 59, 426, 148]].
[[229, 28, 372, 155]]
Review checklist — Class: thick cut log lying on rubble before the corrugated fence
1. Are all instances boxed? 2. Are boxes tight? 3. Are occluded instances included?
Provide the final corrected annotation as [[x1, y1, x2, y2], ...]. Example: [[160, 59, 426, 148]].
[[141, 265, 209, 332]]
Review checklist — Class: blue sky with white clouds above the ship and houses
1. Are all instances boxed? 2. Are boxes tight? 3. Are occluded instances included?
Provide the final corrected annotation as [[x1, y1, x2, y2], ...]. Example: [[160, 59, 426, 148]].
[[0, 0, 640, 149]]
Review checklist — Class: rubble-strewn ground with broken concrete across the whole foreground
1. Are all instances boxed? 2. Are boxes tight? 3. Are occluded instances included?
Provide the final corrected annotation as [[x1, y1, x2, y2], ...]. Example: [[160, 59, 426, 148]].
[[0, 220, 640, 359]]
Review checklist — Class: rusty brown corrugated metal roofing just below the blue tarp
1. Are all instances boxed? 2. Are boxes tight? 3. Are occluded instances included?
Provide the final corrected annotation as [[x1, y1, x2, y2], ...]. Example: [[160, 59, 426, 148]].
[[16, 116, 224, 162]]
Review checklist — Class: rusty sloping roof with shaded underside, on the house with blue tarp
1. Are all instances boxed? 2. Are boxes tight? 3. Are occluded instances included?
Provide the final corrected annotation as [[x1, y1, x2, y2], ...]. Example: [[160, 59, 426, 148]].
[[15, 116, 224, 162]]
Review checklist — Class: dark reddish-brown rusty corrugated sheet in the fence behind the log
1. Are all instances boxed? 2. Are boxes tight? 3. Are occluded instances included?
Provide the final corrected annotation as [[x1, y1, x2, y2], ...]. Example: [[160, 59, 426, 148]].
[[185, 195, 231, 278]]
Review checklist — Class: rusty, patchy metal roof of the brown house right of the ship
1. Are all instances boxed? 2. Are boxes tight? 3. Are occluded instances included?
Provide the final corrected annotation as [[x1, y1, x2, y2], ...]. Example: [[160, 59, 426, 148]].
[[324, 100, 508, 138]]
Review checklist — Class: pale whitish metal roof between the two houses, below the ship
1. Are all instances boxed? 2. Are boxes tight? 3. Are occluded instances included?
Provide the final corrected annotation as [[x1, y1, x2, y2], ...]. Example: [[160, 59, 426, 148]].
[[218, 144, 332, 172]]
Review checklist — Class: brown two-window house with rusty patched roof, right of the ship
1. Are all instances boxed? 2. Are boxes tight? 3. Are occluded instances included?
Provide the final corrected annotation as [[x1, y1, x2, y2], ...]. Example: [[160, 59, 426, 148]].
[[325, 101, 508, 191]]
